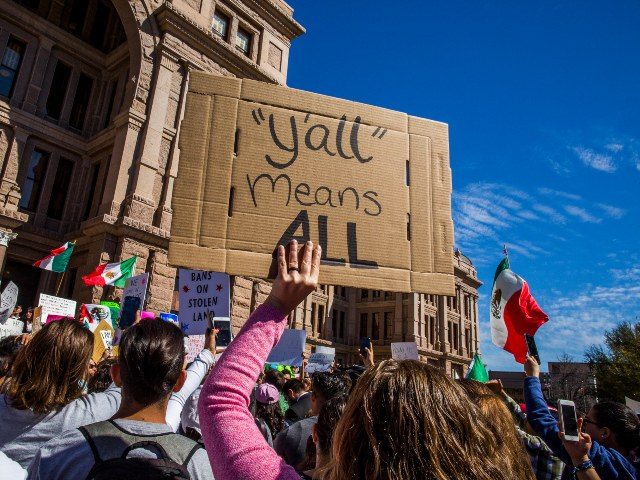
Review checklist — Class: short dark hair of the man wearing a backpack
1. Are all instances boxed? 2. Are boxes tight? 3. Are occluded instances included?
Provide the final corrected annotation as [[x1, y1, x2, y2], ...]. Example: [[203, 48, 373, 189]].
[[118, 319, 184, 405]]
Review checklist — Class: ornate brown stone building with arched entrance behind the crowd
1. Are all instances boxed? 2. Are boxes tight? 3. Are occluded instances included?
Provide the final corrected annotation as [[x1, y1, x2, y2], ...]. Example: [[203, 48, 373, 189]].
[[0, 0, 480, 373]]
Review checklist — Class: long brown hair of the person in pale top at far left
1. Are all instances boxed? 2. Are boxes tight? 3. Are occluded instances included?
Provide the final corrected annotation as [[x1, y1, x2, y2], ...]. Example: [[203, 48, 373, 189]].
[[2, 320, 93, 414]]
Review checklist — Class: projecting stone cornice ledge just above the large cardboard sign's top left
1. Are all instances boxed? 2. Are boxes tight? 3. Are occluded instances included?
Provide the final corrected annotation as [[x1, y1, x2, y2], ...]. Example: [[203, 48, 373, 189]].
[[154, 3, 279, 83]]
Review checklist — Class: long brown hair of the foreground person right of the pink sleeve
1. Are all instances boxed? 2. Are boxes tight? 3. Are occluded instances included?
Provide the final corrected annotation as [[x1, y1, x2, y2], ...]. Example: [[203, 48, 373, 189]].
[[325, 360, 533, 480]]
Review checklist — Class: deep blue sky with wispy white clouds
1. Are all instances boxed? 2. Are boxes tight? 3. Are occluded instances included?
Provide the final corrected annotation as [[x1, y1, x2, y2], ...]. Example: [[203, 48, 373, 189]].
[[288, 0, 640, 370]]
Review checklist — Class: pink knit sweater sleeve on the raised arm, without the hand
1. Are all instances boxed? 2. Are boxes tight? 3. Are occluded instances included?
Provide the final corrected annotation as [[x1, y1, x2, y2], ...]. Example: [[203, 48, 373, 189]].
[[198, 304, 300, 480]]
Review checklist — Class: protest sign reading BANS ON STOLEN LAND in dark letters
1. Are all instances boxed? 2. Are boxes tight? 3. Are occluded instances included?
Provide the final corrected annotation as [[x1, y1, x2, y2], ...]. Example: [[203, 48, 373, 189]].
[[179, 268, 230, 336]]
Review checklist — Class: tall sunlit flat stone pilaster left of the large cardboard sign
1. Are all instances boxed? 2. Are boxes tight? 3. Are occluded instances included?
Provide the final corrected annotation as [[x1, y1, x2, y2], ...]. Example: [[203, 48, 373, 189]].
[[125, 49, 178, 224]]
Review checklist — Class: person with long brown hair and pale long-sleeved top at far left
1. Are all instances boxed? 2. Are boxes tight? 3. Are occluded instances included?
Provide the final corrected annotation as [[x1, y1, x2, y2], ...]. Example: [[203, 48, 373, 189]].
[[0, 320, 120, 468]]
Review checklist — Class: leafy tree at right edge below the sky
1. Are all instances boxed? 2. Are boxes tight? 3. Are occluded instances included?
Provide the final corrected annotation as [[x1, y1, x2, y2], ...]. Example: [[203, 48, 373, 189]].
[[585, 322, 640, 402]]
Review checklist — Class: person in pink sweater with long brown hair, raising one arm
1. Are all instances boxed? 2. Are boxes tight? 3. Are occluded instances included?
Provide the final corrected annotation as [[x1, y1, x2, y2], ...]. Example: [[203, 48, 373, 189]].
[[198, 240, 533, 480]]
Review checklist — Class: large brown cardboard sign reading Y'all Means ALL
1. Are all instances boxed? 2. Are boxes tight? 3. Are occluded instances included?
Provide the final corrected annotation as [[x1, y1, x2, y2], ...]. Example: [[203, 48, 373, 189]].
[[169, 72, 455, 295]]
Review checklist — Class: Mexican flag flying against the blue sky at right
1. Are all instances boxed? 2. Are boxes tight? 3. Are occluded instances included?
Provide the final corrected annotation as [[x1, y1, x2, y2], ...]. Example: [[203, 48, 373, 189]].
[[490, 258, 549, 364]]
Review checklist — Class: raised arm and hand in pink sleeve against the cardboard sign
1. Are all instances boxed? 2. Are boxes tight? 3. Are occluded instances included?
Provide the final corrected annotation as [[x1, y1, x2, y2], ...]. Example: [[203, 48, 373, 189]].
[[198, 241, 320, 480]]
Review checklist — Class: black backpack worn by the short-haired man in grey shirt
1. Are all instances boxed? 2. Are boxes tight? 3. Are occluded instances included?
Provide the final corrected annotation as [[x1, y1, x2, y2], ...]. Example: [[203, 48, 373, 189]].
[[78, 420, 202, 480]]
